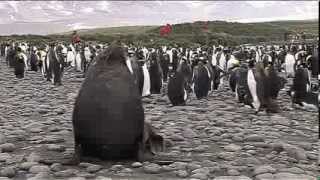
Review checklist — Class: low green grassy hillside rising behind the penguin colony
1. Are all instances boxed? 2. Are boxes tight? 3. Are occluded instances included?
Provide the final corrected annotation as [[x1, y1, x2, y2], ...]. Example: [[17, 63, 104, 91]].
[[1, 20, 319, 46]]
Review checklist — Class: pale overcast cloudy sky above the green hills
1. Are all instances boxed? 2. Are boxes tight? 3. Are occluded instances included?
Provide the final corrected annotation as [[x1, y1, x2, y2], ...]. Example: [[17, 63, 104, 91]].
[[0, 1, 319, 35]]
